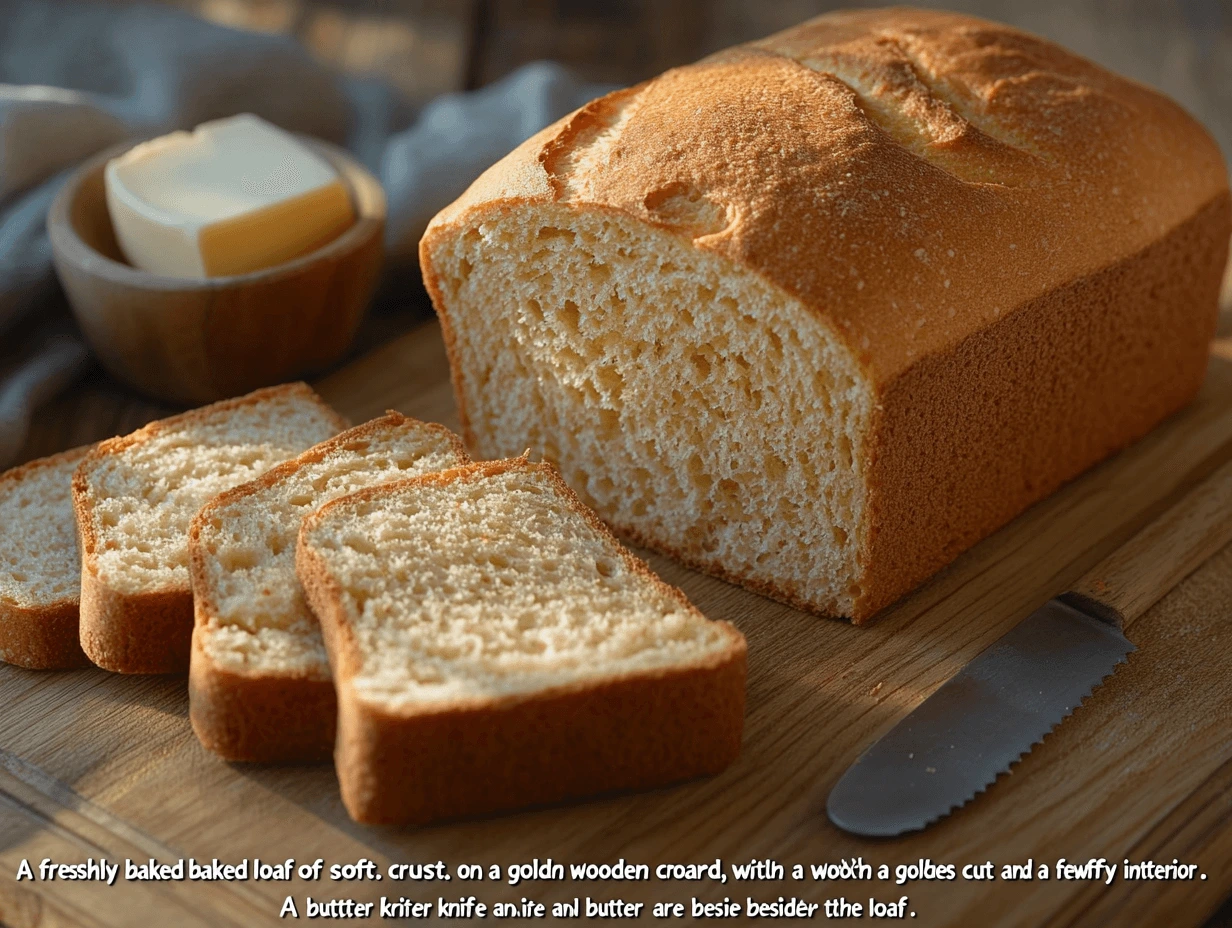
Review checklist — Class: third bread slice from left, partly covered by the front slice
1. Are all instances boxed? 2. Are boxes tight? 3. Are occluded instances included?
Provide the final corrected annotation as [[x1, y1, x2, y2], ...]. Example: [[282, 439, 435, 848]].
[[188, 412, 469, 763]]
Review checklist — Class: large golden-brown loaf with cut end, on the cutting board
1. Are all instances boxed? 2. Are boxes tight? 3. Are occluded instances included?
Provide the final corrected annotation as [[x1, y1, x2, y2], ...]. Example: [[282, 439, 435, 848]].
[[420, 9, 1232, 621]]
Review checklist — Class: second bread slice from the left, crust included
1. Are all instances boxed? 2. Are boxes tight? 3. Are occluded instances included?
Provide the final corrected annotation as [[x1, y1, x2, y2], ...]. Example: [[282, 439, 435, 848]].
[[73, 383, 346, 673]]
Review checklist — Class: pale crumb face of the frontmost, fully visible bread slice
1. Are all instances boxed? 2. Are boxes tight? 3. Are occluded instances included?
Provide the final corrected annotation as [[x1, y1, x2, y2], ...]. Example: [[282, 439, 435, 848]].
[[301, 462, 743, 714]]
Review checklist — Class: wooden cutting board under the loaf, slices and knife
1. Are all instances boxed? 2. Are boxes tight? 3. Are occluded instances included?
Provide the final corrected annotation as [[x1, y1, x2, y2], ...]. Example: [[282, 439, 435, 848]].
[[0, 325, 1232, 928]]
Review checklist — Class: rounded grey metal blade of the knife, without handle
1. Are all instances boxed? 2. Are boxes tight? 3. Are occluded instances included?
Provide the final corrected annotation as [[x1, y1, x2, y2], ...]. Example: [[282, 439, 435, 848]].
[[825, 599, 1135, 837]]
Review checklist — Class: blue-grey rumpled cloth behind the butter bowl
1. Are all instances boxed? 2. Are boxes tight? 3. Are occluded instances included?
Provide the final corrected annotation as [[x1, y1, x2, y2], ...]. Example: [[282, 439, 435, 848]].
[[0, 0, 609, 467]]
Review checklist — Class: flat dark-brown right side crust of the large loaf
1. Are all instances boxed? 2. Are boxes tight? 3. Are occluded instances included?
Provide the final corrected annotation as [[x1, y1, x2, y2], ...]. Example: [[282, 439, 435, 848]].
[[853, 193, 1232, 622]]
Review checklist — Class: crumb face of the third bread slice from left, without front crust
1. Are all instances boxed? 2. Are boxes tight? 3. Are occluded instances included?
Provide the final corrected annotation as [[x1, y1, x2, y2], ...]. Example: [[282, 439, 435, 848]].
[[192, 413, 468, 680]]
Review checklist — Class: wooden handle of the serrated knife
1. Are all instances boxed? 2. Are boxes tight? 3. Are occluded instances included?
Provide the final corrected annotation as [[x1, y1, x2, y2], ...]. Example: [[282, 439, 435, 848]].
[[1061, 462, 1232, 629]]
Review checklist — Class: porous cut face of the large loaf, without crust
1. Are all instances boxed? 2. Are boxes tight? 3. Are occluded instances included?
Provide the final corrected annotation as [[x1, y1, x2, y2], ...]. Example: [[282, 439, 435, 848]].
[[430, 205, 873, 615]]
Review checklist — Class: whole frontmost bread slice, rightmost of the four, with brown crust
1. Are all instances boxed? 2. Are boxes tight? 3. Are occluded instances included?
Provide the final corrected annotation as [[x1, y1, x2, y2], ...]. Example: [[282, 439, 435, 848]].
[[297, 458, 745, 823]]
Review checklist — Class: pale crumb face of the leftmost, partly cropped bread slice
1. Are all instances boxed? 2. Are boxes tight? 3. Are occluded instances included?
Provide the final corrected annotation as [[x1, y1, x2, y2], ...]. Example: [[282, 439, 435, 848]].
[[0, 449, 89, 608]]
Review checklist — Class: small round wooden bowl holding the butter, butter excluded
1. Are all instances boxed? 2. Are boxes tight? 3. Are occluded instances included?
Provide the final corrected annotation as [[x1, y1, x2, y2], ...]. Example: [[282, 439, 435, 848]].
[[47, 139, 386, 404]]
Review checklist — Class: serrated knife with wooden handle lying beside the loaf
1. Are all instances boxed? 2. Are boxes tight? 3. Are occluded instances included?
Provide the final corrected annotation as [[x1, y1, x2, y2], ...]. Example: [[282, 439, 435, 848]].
[[825, 453, 1232, 837]]
